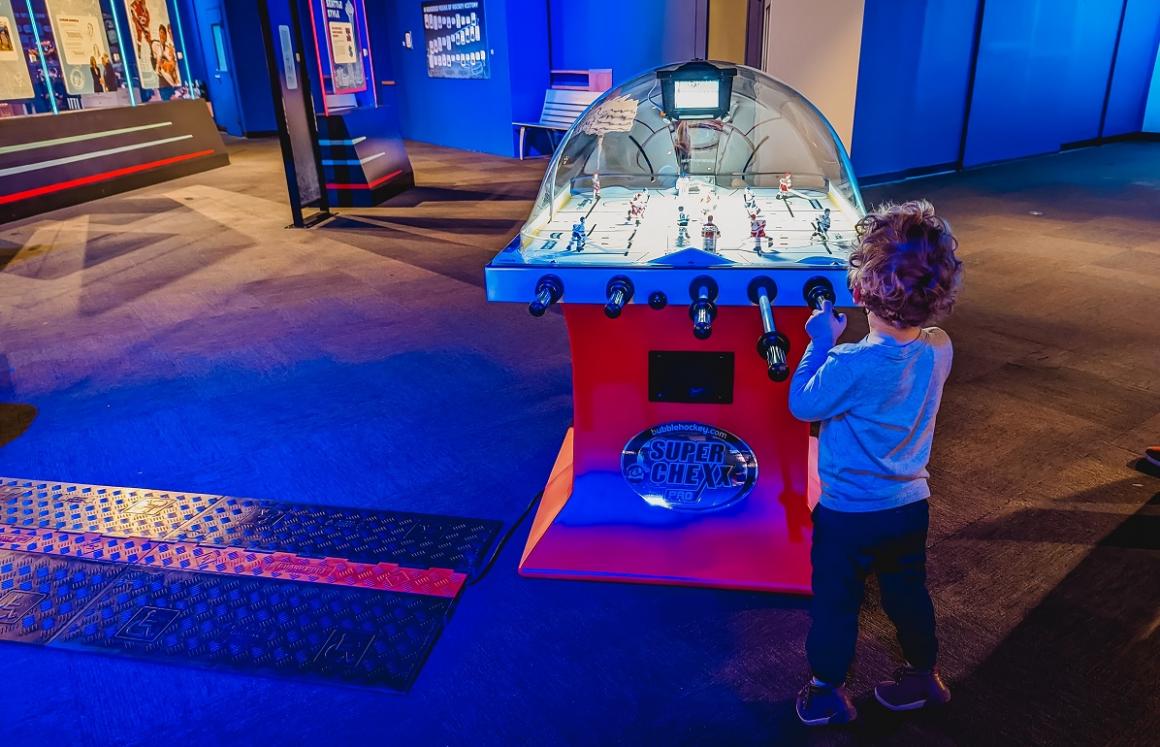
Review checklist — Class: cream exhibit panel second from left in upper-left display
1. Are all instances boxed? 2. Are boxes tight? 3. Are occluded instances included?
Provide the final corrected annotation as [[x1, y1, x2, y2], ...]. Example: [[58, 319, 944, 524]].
[[45, 0, 113, 96]]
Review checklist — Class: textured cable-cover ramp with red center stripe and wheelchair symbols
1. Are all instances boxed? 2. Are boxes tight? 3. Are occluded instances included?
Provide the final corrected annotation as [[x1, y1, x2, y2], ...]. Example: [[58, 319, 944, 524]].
[[0, 479, 500, 690]]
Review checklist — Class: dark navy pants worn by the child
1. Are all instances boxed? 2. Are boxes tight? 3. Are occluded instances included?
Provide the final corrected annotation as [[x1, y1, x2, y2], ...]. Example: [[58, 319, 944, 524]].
[[805, 501, 938, 684]]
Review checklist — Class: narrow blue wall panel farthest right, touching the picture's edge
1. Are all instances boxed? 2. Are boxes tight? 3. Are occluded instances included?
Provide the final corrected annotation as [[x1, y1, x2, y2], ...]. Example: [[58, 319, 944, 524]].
[[1103, 0, 1160, 137]]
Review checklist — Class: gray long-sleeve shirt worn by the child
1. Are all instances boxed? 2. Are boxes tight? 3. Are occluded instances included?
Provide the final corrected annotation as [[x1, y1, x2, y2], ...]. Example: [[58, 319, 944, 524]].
[[790, 327, 952, 512]]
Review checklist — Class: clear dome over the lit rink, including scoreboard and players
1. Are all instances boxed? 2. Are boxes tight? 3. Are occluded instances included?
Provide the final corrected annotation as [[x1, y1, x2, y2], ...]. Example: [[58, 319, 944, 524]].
[[520, 63, 864, 263]]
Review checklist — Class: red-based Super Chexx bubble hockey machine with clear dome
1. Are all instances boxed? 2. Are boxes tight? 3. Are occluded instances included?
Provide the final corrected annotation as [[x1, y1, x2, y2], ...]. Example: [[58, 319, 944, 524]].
[[486, 60, 864, 593]]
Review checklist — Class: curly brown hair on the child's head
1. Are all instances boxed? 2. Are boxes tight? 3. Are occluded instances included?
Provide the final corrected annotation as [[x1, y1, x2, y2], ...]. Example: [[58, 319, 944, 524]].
[[849, 200, 963, 328]]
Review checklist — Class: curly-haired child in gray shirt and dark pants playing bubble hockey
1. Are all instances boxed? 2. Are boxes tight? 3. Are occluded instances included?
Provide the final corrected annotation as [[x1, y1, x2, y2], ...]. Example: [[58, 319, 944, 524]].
[[789, 201, 963, 726]]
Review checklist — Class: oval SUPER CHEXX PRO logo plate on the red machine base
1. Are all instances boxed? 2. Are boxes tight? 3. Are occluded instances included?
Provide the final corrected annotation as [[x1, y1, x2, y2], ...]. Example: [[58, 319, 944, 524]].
[[621, 422, 757, 512]]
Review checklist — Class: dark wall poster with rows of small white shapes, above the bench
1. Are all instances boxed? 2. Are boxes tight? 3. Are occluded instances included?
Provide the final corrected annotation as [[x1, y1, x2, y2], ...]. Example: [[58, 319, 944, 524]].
[[422, 0, 491, 79]]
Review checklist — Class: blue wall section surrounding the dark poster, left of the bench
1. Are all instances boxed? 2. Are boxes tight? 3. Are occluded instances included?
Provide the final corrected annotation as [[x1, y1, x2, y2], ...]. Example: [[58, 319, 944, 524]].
[[380, 0, 548, 155]]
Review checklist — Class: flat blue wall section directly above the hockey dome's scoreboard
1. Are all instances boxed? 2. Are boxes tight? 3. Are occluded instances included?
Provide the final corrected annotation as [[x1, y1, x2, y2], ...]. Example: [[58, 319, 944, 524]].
[[550, 0, 708, 84]]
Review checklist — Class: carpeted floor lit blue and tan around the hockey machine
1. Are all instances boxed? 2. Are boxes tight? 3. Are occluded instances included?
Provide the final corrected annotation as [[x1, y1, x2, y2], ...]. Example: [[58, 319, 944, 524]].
[[0, 136, 1160, 747]]
